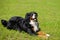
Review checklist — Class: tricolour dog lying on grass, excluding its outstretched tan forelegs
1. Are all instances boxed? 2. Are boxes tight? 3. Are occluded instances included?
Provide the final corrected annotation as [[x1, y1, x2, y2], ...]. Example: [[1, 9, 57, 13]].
[[1, 12, 40, 35]]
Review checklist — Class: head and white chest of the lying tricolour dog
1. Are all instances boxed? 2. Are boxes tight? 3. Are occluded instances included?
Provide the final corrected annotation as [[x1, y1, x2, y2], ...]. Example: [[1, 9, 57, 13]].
[[25, 12, 40, 32]]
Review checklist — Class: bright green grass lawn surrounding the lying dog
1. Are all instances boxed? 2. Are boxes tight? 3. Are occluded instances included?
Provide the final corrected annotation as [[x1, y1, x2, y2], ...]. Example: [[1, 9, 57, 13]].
[[0, 0, 60, 40]]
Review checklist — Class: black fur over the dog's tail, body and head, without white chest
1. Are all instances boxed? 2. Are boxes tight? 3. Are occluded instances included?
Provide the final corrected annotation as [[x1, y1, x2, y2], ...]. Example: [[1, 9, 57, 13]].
[[1, 12, 40, 35]]
